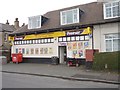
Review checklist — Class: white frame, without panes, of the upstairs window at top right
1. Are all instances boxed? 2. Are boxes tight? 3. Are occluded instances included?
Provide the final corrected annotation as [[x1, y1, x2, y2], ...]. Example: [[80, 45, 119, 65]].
[[103, 0, 120, 19]]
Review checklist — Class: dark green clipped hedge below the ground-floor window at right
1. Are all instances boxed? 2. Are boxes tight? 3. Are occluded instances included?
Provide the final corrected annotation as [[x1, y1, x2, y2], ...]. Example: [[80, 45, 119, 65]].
[[92, 51, 120, 71]]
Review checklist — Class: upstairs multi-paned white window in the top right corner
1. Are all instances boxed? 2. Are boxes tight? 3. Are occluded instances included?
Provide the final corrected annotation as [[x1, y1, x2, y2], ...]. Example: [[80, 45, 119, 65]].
[[104, 0, 120, 19]]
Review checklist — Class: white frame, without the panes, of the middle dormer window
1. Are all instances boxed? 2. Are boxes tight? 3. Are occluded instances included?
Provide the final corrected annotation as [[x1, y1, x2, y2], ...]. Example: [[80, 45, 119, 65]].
[[60, 8, 80, 25]]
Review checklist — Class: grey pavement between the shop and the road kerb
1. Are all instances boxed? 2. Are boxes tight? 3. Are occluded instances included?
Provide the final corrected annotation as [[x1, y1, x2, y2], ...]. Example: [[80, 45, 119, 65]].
[[2, 63, 120, 84]]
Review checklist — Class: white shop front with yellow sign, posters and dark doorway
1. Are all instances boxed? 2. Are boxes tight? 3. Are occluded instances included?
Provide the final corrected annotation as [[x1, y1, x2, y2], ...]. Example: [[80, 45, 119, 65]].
[[9, 27, 92, 63]]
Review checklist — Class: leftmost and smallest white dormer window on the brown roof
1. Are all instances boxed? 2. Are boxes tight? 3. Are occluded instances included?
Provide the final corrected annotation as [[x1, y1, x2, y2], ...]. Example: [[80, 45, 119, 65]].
[[28, 15, 41, 29]]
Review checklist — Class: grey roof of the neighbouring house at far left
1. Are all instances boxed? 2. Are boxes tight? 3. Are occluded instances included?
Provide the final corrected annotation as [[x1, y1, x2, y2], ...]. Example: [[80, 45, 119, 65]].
[[0, 23, 15, 32]]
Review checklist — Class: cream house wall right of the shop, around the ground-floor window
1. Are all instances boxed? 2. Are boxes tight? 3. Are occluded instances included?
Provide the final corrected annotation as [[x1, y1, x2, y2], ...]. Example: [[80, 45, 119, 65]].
[[93, 22, 120, 52]]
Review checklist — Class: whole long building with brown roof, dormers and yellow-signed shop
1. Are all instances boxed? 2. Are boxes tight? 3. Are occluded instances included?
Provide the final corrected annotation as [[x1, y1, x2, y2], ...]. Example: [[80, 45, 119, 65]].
[[9, 0, 120, 63]]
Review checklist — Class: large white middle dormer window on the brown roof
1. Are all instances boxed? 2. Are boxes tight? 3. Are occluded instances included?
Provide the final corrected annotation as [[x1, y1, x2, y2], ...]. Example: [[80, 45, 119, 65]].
[[60, 8, 79, 25]]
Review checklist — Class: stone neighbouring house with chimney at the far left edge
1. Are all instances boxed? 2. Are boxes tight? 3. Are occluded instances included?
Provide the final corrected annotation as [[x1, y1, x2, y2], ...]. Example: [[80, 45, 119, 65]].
[[0, 21, 16, 59]]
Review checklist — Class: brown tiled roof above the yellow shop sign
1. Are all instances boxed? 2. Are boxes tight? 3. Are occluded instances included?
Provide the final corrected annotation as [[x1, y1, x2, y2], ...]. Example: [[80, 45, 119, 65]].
[[10, 2, 118, 34]]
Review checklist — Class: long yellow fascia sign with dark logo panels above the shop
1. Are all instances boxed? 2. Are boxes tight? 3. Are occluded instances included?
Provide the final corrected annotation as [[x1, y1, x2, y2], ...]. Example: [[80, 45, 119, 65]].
[[9, 27, 92, 41]]
